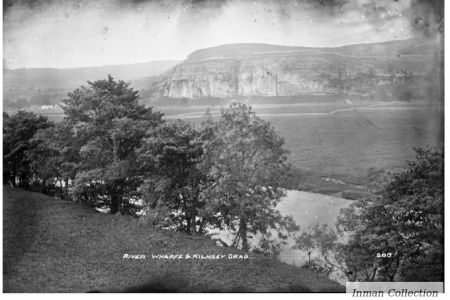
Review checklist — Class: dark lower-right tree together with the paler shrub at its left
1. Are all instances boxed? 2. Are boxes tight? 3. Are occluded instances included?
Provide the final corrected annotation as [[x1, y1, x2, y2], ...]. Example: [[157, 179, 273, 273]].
[[295, 148, 444, 281]]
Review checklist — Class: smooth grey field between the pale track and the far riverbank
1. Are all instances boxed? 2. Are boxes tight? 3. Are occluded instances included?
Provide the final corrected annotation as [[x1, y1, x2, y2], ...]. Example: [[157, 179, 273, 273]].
[[265, 103, 441, 185]]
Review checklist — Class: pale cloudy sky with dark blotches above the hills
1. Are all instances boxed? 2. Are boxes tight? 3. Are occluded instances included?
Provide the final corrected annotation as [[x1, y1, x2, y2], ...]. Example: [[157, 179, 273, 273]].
[[3, 0, 443, 69]]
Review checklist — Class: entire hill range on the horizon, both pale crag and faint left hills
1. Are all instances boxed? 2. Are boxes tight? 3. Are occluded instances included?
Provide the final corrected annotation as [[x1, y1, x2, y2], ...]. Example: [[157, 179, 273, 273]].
[[3, 39, 443, 111]]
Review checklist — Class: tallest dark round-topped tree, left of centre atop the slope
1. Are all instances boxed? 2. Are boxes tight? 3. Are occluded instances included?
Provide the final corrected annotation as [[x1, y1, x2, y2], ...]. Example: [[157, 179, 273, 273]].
[[62, 76, 162, 214]]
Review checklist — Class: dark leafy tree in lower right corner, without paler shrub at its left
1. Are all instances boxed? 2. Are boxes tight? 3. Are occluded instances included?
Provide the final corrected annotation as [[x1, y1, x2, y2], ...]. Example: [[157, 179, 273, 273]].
[[338, 148, 444, 281]]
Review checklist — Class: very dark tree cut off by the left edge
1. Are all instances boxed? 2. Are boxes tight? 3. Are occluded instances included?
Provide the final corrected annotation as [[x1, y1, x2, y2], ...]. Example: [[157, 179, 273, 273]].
[[3, 111, 53, 188]]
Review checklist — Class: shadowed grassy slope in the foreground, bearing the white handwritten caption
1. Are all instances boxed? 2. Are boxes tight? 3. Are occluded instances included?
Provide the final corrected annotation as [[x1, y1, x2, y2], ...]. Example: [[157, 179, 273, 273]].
[[3, 186, 344, 292]]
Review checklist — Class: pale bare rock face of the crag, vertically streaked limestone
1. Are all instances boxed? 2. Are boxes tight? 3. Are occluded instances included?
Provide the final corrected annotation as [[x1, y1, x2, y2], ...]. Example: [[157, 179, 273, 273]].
[[165, 56, 325, 98]]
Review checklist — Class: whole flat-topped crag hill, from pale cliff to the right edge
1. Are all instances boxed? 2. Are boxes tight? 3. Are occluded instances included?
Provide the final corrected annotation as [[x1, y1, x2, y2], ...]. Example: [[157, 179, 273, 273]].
[[153, 40, 439, 98]]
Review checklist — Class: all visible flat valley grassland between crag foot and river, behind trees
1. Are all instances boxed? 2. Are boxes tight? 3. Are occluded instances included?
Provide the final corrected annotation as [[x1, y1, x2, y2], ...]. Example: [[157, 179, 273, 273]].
[[24, 98, 443, 199]]
